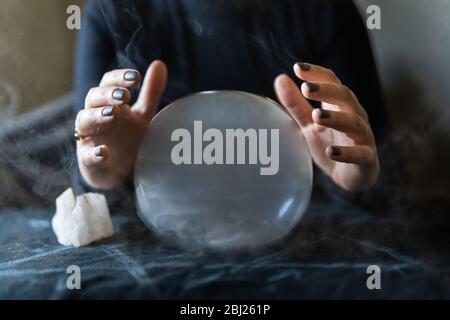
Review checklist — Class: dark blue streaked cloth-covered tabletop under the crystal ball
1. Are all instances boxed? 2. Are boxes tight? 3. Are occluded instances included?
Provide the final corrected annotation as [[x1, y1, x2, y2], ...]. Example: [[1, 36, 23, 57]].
[[0, 204, 450, 299]]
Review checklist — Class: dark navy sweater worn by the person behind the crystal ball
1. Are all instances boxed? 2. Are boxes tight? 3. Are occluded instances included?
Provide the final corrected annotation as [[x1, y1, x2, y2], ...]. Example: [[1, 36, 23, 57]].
[[74, 0, 387, 209]]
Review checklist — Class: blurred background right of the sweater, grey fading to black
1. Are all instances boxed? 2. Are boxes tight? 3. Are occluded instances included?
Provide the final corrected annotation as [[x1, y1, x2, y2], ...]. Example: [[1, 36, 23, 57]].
[[356, 0, 450, 198]]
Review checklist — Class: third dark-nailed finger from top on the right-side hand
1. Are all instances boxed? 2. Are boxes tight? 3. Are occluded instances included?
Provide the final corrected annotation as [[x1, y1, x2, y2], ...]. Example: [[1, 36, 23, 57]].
[[312, 109, 373, 144]]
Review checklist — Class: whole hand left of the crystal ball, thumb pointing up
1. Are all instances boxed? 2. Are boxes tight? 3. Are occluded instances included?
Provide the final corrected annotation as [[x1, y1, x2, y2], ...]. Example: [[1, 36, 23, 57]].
[[75, 61, 167, 189]]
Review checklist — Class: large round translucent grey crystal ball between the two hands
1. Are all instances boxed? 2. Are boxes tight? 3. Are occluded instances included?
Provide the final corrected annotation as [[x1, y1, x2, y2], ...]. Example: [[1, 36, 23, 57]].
[[135, 91, 312, 250]]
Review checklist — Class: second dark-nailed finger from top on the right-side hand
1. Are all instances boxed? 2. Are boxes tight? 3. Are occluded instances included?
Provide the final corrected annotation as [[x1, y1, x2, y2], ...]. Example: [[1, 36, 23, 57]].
[[301, 82, 367, 119]]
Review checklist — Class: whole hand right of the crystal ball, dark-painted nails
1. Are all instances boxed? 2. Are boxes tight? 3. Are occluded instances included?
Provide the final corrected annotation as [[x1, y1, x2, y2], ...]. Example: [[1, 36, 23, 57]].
[[275, 63, 380, 192]]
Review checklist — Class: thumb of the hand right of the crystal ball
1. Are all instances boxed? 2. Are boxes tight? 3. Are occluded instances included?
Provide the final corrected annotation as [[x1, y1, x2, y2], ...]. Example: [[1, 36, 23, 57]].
[[275, 75, 313, 127]]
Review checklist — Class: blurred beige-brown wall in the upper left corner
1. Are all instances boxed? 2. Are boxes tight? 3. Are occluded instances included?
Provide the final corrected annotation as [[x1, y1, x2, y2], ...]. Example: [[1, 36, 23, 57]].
[[0, 0, 83, 116]]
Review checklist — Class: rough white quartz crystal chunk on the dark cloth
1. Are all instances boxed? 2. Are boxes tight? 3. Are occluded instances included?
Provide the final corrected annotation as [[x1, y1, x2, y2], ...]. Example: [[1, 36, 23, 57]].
[[52, 188, 114, 247]]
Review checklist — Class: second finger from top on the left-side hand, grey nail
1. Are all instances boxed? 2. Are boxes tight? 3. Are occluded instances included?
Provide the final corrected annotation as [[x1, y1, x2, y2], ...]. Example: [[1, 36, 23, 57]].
[[84, 86, 131, 109]]
